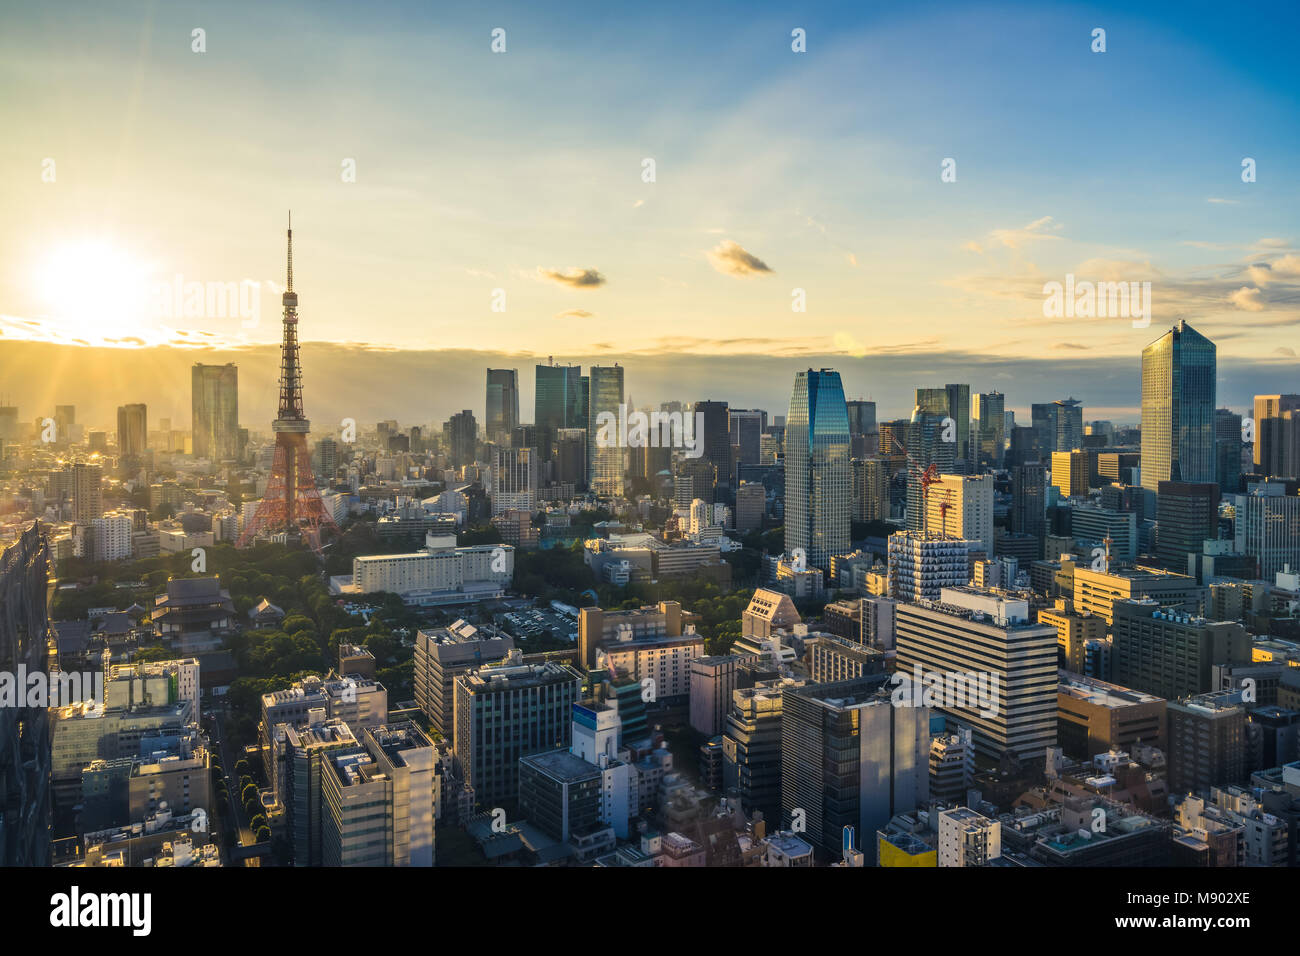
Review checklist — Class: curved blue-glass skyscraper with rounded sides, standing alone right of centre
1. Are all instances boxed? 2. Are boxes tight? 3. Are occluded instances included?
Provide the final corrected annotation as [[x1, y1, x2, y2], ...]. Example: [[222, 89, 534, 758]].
[[785, 368, 853, 571]]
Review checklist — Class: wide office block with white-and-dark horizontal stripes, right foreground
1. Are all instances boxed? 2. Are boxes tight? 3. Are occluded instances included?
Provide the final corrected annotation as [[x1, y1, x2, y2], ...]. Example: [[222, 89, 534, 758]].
[[894, 588, 1058, 763]]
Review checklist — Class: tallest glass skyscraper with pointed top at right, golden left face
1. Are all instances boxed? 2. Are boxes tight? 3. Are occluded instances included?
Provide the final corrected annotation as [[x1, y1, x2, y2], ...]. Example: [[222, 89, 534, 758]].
[[1141, 321, 1217, 492]]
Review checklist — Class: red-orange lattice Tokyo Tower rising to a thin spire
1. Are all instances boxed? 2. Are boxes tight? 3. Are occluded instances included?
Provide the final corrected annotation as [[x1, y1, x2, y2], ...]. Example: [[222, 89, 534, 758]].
[[237, 213, 338, 551]]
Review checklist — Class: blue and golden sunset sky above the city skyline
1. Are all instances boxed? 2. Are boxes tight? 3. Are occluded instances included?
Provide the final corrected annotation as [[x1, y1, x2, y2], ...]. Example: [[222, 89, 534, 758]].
[[0, 0, 1300, 420]]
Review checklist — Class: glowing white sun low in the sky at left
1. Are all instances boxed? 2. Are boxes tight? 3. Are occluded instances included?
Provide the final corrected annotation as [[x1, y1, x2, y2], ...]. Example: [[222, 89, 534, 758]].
[[34, 238, 156, 342]]
